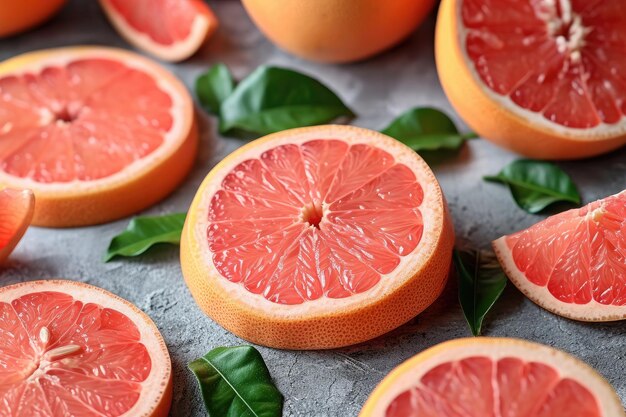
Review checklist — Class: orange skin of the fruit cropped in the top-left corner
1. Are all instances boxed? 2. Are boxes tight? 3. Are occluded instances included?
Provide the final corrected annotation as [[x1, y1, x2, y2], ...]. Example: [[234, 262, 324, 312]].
[[0, 0, 66, 38]]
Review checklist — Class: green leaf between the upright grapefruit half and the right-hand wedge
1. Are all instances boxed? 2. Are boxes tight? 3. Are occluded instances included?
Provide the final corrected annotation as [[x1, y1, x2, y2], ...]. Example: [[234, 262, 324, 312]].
[[484, 159, 580, 213]]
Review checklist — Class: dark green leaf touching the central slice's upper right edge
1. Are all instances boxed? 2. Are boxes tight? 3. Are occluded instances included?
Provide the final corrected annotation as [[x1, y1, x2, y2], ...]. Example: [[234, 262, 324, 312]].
[[382, 107, 476, 152]]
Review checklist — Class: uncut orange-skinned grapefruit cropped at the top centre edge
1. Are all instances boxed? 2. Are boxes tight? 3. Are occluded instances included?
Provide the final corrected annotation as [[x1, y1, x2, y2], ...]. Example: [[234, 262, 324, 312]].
[[243, 0, 434, 62]]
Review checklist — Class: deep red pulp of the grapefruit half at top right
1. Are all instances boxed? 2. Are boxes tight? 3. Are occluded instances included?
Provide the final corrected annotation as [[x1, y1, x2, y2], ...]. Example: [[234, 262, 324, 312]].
[[461, 0, 626, 128]]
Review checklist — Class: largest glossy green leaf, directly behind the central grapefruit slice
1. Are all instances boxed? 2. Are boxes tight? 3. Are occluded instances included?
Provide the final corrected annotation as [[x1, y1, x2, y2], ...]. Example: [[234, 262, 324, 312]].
[[220, 66, 354, 135]]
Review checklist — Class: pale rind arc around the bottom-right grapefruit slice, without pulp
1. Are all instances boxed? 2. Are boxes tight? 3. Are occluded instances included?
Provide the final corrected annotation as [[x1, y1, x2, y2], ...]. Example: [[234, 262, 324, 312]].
[[359, 337, 626, 417]]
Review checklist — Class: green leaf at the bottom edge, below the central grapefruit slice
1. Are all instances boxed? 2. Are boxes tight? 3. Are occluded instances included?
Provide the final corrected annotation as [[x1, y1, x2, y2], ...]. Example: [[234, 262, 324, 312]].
[[189, 346, 283, 417]]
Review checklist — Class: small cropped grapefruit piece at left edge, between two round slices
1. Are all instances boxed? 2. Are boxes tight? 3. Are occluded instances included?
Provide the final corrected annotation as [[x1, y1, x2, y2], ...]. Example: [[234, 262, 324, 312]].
[[0, 188, 35, 264]]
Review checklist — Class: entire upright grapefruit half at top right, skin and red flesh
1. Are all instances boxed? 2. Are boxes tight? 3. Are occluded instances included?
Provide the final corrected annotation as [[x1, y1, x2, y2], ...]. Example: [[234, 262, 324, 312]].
[[435, 0, 626, 159]]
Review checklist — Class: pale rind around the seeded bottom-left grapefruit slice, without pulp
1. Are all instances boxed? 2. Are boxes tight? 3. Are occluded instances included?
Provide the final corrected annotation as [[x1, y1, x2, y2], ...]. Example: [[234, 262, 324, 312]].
[[0, 280, 173, 417]]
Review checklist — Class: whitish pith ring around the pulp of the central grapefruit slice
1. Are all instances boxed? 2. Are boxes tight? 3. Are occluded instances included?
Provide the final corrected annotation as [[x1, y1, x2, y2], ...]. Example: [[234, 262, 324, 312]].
[[190, 126, 444, 319]]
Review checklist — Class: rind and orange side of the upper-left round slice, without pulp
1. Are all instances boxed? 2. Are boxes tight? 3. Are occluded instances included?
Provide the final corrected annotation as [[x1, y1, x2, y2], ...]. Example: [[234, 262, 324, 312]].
[[0, 46, 198, 227]]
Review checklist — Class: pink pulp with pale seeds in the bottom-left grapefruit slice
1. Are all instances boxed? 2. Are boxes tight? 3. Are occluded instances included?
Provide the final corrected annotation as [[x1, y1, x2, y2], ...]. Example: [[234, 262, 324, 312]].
[[0, 291, 152, 417]]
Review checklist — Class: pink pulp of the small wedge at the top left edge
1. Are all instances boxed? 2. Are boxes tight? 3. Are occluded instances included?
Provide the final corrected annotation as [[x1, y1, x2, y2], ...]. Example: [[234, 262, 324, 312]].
[[109, 0, 208, 45]]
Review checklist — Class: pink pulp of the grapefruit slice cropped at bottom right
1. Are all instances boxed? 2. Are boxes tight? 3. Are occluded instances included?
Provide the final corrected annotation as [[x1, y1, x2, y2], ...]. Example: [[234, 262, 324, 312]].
[[385, 356, 602, 417]]
